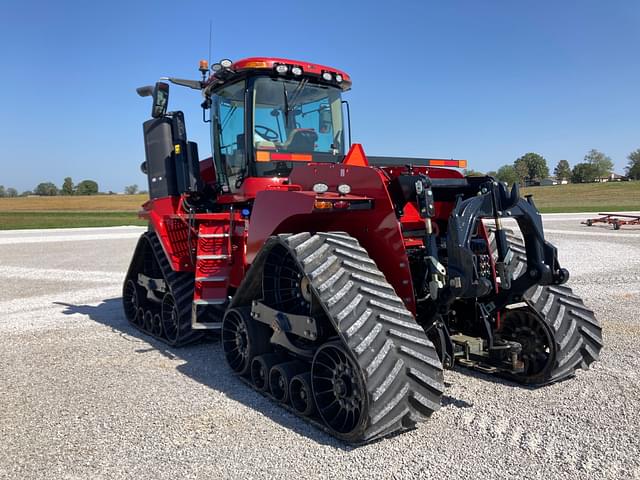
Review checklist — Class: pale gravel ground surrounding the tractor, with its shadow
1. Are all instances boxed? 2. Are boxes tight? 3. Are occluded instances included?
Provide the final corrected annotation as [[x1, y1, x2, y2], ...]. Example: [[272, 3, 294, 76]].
[[0, 215, 640, 479]]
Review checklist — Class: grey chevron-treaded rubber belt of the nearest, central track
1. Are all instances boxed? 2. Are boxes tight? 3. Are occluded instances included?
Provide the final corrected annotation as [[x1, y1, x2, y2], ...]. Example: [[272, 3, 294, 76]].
[[280, 233, 444, 442]]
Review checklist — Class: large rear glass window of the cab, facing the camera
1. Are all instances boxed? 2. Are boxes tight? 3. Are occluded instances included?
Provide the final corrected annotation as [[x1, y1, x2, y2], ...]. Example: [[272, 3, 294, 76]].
[[253, 77, 344, 175]]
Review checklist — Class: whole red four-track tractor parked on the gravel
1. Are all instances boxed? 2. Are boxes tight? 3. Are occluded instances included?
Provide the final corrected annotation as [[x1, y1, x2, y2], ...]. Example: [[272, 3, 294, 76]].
[[123, 58, 602, 443]]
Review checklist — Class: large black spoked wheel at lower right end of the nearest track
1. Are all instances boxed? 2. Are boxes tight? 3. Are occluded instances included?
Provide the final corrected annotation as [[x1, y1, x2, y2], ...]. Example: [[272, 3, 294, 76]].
[[311, 342, 368, 440]]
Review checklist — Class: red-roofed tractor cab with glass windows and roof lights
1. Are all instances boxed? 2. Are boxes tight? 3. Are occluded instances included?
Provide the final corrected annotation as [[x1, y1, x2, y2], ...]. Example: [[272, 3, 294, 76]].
[[203, 58, 351, 197]]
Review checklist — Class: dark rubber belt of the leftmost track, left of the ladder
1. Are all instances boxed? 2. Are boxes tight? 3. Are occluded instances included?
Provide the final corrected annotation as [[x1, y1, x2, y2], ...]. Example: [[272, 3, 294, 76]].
[[127, 232, 203, 347]]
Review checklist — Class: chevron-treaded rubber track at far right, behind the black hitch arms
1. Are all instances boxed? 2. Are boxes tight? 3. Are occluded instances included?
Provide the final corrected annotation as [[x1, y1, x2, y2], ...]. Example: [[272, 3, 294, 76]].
[[489, 227, 603, 383]]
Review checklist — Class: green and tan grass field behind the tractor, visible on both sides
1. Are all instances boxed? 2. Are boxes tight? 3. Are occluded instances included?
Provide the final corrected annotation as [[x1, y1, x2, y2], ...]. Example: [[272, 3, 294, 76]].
[[0, 182, 640, 230]]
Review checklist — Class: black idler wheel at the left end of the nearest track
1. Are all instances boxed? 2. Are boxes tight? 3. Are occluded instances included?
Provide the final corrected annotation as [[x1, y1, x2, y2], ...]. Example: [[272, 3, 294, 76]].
[[222, 308, 271, 376]]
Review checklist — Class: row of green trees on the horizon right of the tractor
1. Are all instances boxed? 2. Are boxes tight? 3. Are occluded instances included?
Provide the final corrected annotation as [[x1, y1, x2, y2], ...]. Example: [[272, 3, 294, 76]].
[[467, 148, 640, 185]]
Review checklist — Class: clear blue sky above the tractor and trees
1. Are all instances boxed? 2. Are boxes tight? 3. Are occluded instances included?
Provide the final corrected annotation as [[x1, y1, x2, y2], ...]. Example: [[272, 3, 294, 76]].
[[0, 0, 640, 191]]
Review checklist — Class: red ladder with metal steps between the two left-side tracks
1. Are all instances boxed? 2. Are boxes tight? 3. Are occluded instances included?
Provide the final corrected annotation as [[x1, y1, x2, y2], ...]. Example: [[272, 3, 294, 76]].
[[191, 218, 233, 330]]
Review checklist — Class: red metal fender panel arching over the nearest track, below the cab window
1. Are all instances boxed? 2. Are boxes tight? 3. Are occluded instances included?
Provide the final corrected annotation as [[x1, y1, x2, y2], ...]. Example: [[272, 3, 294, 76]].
[[247, 164, 415, 312]]
